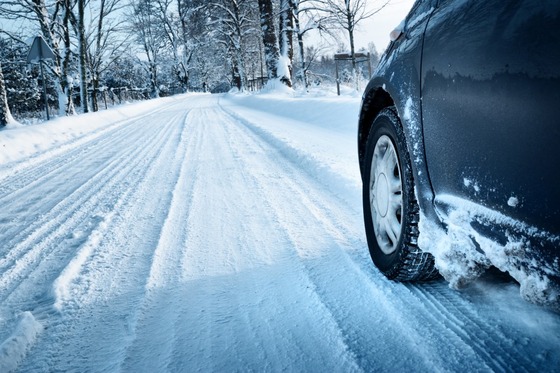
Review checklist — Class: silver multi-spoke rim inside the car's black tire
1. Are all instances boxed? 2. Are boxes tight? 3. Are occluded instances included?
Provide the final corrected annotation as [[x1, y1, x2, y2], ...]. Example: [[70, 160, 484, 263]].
[[369, 135, 403, 255]]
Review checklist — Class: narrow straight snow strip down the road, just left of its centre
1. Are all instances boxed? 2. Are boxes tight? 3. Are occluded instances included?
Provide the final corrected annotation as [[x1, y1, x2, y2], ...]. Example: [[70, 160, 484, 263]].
[[121, 109, 204, 371]]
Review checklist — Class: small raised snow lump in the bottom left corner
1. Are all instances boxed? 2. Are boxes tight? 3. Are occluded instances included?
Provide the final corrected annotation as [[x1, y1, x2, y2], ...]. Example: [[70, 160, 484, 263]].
[[0, 312, 43, 372]]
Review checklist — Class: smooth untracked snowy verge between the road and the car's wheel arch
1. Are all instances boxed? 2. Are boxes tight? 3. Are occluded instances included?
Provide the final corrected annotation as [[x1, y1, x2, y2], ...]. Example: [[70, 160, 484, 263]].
[[220, 92, 361, 206]]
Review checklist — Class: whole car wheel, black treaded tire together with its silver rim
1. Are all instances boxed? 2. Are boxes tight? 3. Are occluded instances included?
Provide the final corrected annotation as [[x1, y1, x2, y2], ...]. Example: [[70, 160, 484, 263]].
[[363, 107, 438, 281]]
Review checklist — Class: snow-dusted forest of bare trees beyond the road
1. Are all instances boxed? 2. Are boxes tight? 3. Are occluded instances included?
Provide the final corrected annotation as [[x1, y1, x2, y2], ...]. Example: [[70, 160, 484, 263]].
[[0, 0, 389, 126]]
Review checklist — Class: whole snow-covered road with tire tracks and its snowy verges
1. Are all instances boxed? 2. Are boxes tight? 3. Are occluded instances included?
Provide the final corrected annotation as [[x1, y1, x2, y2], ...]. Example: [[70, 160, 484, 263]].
[[0, 95, 560, 372]]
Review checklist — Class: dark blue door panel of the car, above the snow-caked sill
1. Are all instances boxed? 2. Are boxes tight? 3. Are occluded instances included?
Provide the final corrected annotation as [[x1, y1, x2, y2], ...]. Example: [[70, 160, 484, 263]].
[[422, 0, 560, 232]]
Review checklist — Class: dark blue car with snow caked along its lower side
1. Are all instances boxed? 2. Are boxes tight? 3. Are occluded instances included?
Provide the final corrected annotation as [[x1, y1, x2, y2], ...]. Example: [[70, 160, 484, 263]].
[[358, 0, 560, 307]]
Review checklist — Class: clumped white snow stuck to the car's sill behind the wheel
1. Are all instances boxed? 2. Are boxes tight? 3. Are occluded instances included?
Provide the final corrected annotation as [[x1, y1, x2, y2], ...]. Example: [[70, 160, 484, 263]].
[[418, 195, 560, 309]]
